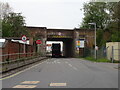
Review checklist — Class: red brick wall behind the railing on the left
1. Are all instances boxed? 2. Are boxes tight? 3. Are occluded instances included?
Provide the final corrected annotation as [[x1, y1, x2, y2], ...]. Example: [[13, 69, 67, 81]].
[[0, 40, 34, 61]]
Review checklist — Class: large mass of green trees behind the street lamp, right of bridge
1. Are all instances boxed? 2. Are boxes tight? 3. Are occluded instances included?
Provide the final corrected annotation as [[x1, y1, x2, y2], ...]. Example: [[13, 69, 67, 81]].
[[80, 2, 120, 46]]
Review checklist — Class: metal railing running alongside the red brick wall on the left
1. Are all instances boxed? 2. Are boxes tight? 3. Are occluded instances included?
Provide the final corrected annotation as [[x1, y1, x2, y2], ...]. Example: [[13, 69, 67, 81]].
[[0, 52, 44, 73]]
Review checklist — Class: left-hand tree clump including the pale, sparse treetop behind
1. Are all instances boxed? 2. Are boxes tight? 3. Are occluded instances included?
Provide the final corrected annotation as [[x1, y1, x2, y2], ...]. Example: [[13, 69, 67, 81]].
[[0, 2, 29, 37]]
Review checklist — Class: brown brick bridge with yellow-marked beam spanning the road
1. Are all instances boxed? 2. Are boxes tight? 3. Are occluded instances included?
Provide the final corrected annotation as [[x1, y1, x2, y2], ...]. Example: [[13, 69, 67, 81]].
[[27, 27, 94, 57]]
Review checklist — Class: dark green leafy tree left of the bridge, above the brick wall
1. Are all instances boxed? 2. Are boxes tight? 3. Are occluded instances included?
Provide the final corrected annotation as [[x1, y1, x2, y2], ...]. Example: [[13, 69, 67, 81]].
[[2, 13, 28, 37]]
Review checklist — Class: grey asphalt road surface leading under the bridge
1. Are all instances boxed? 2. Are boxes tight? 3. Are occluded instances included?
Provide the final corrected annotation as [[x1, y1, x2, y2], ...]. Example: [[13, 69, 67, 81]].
[[0, 58, 118, 88]]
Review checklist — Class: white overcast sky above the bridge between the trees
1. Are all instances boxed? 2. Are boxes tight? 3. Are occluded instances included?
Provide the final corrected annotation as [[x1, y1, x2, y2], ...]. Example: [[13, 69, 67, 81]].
[[2, 0, 89, 29]]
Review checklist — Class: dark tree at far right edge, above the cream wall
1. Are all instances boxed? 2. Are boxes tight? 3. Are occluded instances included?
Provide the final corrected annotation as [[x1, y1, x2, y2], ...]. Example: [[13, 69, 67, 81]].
[[107, 2, 120, 42]]
